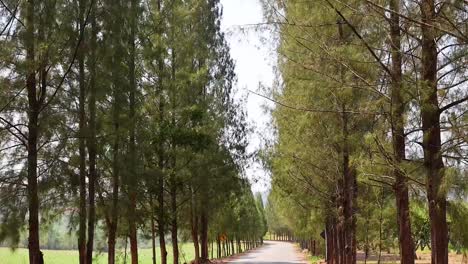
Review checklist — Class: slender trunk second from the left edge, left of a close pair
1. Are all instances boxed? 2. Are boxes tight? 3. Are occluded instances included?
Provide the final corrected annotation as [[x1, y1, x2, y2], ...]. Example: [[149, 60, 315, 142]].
[[77, 0, 87, 264]]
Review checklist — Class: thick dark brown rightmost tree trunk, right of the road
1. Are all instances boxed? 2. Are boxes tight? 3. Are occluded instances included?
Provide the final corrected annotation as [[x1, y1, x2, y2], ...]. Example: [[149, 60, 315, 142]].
[[420, 0, 448, 264]]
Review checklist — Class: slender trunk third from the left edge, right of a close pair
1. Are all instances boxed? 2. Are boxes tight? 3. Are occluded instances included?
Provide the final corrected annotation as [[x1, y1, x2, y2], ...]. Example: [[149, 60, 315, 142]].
[[86, 1, 97, 264]]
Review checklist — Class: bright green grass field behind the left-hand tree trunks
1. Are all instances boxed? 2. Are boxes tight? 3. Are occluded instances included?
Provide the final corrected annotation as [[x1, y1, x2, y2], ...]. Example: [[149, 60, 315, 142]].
[[0, 243, 194, 264]]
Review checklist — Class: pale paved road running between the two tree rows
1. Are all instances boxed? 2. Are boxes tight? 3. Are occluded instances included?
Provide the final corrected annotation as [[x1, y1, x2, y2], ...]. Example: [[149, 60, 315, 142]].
[[227, 241, 307, 264]]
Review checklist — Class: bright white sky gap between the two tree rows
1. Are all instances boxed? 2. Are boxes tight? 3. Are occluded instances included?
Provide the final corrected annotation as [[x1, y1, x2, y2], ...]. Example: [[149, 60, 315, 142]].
[[221, 0, 275, 193]]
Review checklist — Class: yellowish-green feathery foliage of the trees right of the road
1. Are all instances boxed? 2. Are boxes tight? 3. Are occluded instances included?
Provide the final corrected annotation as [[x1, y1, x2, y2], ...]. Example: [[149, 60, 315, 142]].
[[262, 1, 468, 258]]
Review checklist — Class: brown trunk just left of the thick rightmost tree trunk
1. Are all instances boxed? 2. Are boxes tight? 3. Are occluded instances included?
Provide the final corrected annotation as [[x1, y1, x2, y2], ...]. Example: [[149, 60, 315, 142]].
[[390, 0, 414, 264]]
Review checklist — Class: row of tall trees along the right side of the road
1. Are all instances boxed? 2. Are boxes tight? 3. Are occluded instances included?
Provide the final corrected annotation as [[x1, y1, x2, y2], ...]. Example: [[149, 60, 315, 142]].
[[264, 0, 468, 264]]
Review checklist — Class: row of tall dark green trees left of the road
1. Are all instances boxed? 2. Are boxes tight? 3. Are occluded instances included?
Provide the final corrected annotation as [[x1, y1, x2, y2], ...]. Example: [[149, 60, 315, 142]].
[[0, 0, 265, 264]]
